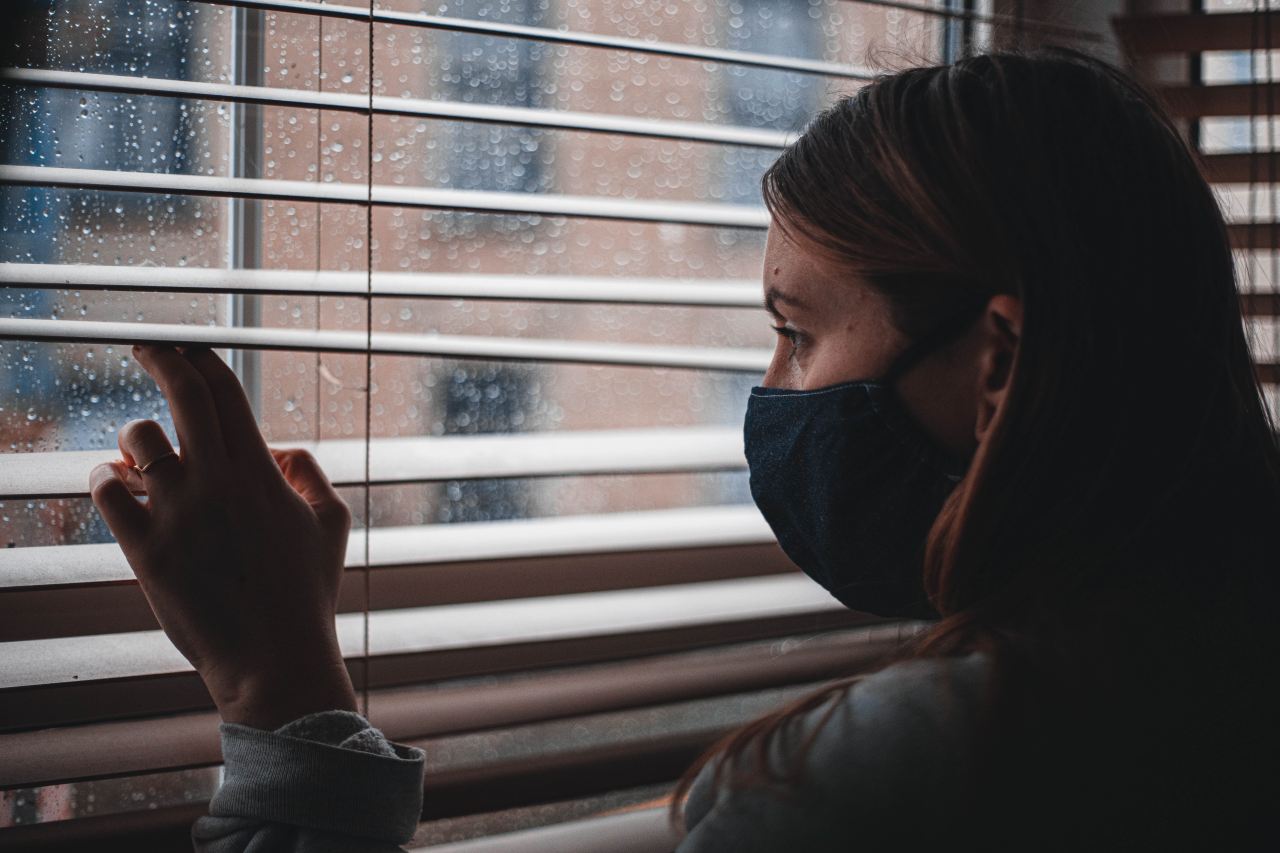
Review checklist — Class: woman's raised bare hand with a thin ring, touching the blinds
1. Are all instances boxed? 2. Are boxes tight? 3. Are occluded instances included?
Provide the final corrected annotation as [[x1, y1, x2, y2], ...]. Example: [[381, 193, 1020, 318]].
[[90, 346, 356, 729]]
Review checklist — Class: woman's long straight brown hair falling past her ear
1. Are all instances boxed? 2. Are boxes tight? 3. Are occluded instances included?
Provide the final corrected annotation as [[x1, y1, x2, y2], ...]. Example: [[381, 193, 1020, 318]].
[[673, 49, 1280, 835]]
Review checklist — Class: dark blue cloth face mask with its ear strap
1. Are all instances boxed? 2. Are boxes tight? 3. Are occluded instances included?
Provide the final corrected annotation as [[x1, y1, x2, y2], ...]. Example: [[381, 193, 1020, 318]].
[[745, 313, 973, 617]]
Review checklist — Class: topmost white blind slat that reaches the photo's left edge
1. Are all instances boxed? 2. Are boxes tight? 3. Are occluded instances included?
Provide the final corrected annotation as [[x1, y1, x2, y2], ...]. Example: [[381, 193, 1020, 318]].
[[0, 68, 794, 149]]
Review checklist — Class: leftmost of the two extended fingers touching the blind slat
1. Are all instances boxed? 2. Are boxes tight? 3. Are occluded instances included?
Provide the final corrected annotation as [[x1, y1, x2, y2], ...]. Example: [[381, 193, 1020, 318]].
[[133, 345, 227, 466]]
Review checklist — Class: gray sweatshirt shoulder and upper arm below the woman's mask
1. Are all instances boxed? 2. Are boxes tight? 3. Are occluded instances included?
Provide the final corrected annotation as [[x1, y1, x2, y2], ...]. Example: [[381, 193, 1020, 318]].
[[677, 654, 987, 853]]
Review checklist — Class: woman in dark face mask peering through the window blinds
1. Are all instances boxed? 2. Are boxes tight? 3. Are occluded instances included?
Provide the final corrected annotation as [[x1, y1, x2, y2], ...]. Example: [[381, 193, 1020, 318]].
[[92, 51, 1280, 853]]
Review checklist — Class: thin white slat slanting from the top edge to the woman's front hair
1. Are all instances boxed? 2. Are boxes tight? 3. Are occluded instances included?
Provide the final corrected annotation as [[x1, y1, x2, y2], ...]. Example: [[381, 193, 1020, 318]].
[[189, 0, 874, 79]]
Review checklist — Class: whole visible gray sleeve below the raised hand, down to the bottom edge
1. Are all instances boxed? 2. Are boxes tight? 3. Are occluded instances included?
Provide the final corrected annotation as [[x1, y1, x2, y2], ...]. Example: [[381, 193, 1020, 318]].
[[192, 711, 424, 853]]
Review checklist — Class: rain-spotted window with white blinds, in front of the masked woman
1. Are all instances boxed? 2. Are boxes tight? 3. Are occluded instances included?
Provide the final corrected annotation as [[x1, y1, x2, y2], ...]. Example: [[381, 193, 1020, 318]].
[[0, 0, 1003, 838]]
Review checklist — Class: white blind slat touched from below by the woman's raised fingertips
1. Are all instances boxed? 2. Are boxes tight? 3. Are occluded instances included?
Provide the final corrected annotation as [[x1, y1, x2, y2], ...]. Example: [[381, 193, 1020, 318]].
[[0, 319, 772, 373]]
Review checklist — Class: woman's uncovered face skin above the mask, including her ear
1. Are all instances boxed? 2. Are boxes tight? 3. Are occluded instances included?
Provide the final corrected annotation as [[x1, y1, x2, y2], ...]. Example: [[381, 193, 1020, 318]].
[[764, 219, 1020, 457]]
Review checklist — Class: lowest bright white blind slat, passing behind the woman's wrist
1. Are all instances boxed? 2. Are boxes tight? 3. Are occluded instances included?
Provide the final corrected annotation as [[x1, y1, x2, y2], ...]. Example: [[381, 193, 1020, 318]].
[[0, 574, 844, 690]]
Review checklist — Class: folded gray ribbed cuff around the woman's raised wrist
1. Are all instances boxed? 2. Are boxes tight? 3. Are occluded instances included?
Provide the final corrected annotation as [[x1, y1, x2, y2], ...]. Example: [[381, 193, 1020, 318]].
[[209, 711, 425, 844]]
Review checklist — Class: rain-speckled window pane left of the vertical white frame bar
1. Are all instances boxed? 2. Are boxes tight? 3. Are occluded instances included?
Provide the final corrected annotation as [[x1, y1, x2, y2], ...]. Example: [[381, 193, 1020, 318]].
[[0, 0, 230, 547]]
